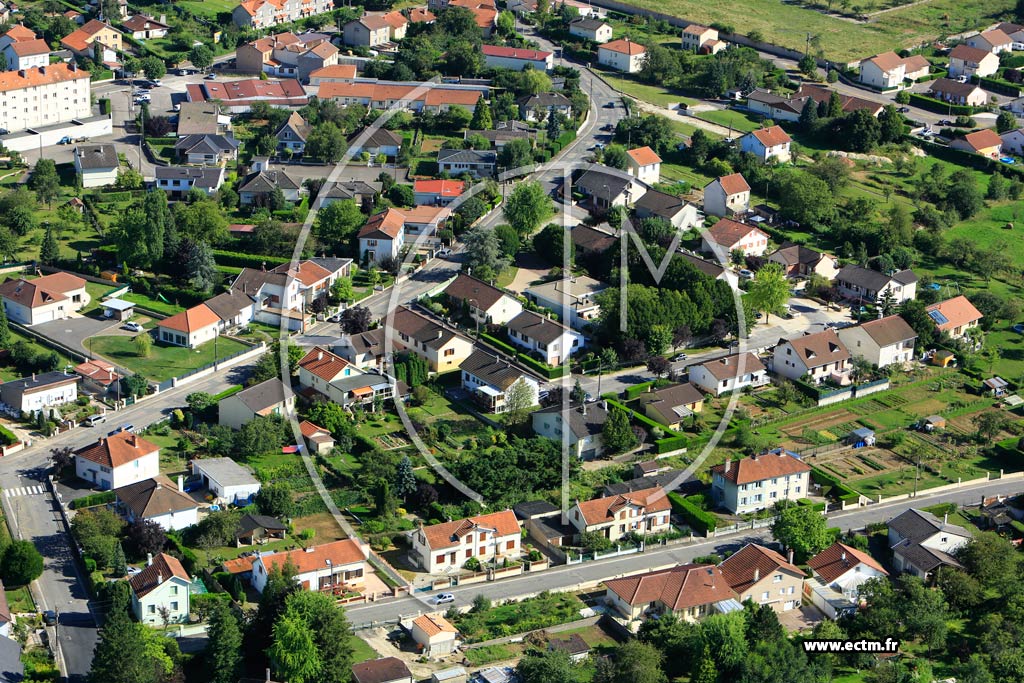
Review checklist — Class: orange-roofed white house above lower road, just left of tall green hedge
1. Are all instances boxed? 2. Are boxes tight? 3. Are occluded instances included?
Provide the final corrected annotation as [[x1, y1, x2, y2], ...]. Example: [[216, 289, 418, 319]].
[[568, 486, 672, 543]]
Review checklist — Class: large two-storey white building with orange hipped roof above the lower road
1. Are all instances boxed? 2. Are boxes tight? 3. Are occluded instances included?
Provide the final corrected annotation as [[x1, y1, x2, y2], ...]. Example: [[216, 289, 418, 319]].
[[711, 449, 811, 515]]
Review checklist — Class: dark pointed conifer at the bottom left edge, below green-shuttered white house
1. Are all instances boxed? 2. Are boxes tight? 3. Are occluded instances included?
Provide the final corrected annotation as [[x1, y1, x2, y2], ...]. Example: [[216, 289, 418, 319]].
[[88, 591, 159, 683]]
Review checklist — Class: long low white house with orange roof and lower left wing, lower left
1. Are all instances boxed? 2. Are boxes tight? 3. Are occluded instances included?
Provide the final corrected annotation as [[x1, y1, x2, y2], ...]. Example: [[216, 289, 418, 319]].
[[252, 539, 370, 593]]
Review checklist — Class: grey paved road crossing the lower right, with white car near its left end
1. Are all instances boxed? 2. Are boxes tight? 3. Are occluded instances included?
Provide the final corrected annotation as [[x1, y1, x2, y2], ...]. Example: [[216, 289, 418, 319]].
[[346, 479, 1024, 627]]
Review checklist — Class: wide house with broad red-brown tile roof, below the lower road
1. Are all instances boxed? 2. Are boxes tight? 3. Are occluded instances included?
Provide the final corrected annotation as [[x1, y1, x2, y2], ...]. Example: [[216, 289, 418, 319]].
[[604, 564, 742, 629]]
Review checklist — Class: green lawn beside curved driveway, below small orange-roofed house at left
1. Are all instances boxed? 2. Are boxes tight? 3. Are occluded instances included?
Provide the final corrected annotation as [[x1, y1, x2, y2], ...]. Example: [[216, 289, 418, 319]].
[[88, 335, 248, 382]]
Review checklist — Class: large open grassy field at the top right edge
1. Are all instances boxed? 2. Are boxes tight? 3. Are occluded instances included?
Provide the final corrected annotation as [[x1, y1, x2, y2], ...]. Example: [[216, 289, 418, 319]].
[[629, 0, 1013, 62]]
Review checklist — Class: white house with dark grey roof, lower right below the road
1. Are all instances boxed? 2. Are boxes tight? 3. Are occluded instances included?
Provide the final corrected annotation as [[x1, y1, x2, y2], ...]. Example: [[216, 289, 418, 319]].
[[889, 508, 971, 580]]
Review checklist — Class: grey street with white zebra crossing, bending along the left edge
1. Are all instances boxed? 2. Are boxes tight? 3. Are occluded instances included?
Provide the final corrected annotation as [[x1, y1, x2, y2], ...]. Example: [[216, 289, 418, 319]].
[[0, 366, 251, 683]]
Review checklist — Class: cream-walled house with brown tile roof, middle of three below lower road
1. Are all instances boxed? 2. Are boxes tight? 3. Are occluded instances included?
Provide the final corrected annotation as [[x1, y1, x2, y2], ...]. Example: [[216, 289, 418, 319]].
[[718, 543, 806, 612]]
